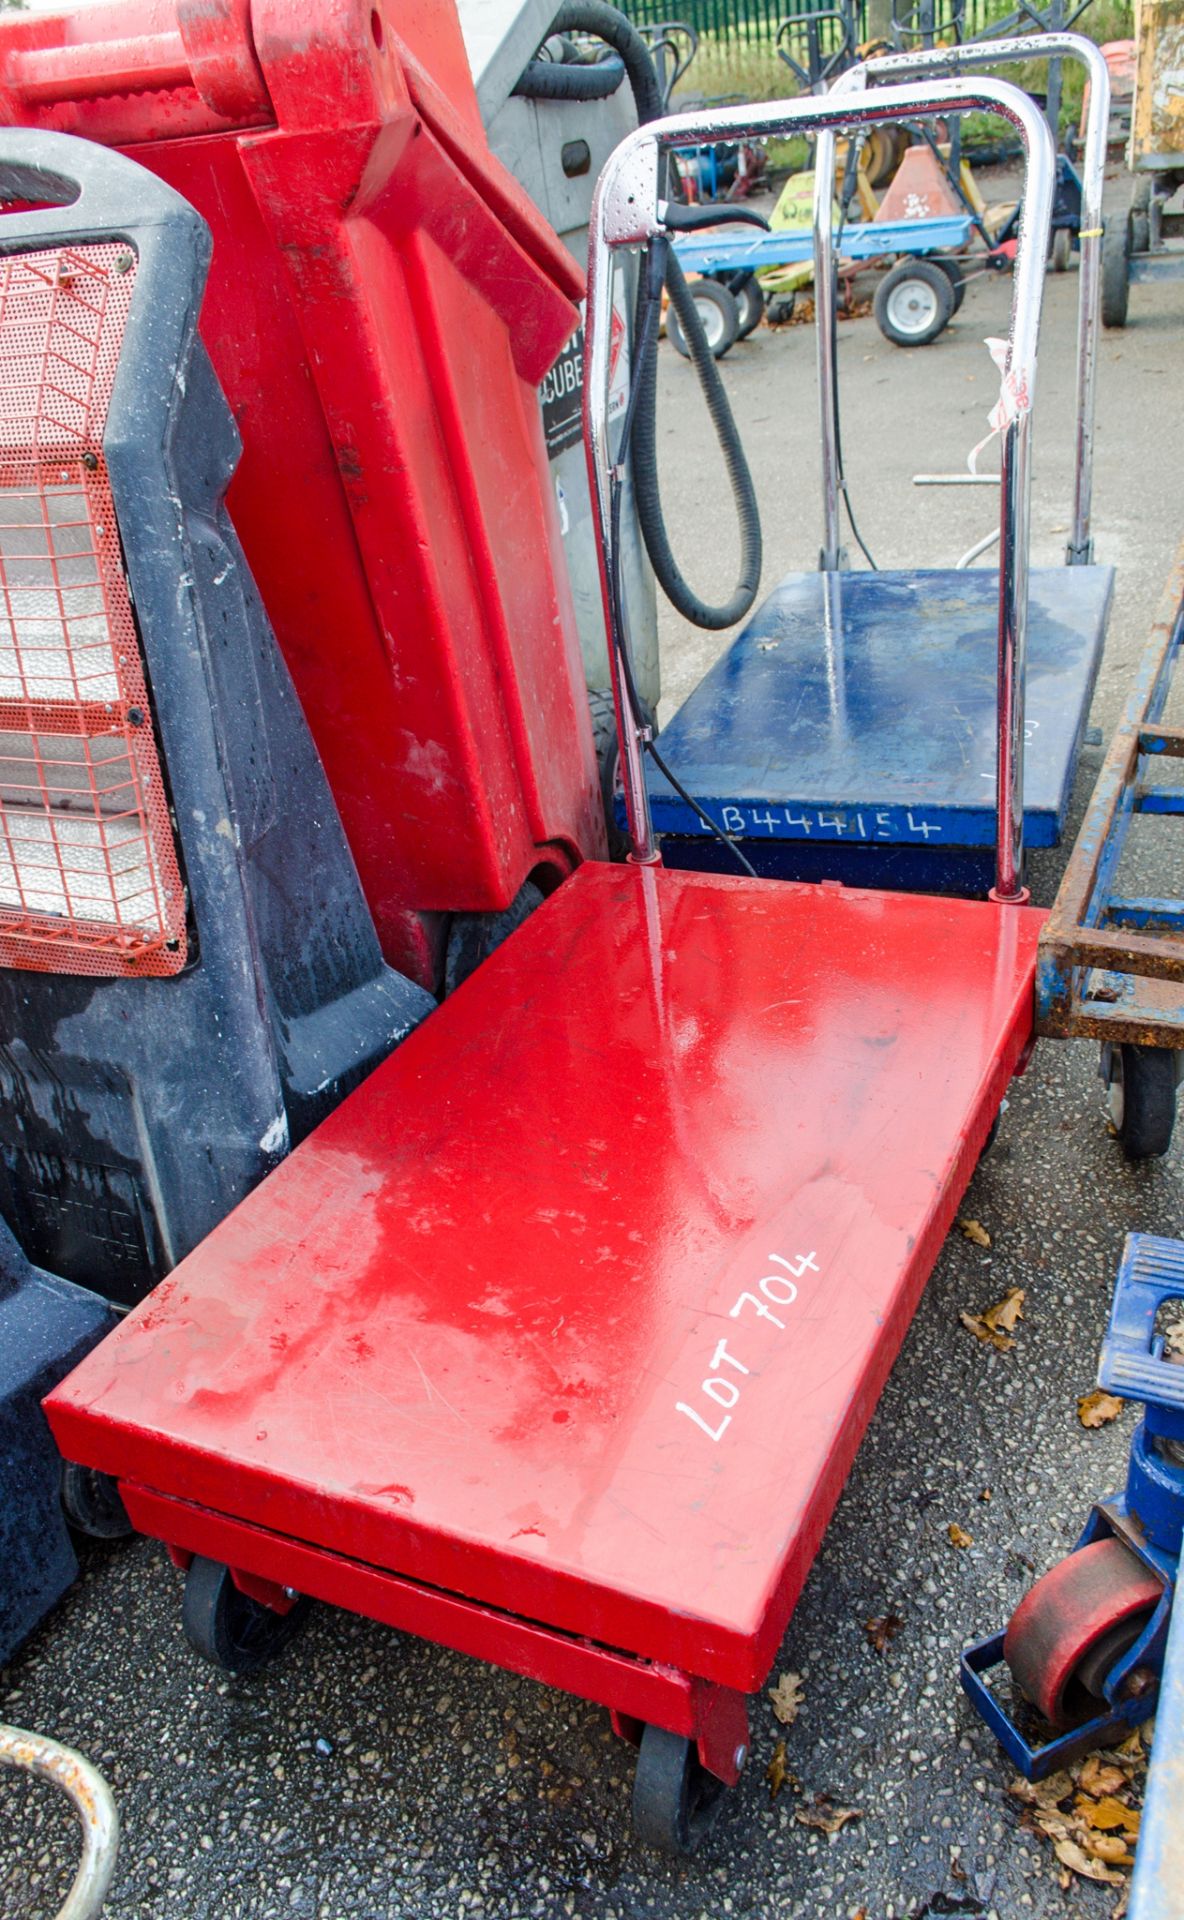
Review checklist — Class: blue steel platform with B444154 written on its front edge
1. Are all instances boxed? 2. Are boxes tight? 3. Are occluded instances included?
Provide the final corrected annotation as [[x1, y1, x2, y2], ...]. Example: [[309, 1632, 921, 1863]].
[[649, 566, 1113, 893]]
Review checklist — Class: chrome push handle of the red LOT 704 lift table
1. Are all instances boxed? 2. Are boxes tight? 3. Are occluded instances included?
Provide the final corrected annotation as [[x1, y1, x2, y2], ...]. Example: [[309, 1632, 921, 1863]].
[[583, 79, 1055, 900]]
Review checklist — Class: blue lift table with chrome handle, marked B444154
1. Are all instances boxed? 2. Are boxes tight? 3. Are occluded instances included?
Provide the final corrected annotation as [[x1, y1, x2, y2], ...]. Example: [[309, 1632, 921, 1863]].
[[647, 35, 1113, 895]]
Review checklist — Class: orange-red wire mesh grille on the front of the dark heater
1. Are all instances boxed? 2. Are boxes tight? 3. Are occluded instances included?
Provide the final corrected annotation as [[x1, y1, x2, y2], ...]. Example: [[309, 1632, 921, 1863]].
[[0, 244, 186, 975]]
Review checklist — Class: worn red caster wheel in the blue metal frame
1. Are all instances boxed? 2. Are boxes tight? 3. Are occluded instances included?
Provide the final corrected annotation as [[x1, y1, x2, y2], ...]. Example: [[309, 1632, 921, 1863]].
[[1004, 1534, 1163, 1732]]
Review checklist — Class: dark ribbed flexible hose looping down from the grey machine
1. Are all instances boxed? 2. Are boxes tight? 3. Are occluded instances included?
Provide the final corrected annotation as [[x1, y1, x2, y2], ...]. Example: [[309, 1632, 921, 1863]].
[[516, 0, 762, 630]]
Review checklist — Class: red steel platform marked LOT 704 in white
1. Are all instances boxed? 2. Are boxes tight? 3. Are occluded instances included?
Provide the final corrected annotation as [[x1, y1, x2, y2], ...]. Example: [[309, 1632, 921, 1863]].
[[48, 864, 1044, 1703]]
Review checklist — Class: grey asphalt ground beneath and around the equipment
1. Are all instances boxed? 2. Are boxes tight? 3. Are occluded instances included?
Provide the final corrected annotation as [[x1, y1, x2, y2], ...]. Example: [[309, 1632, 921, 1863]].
[[0, 165, 1184, 1920]]
